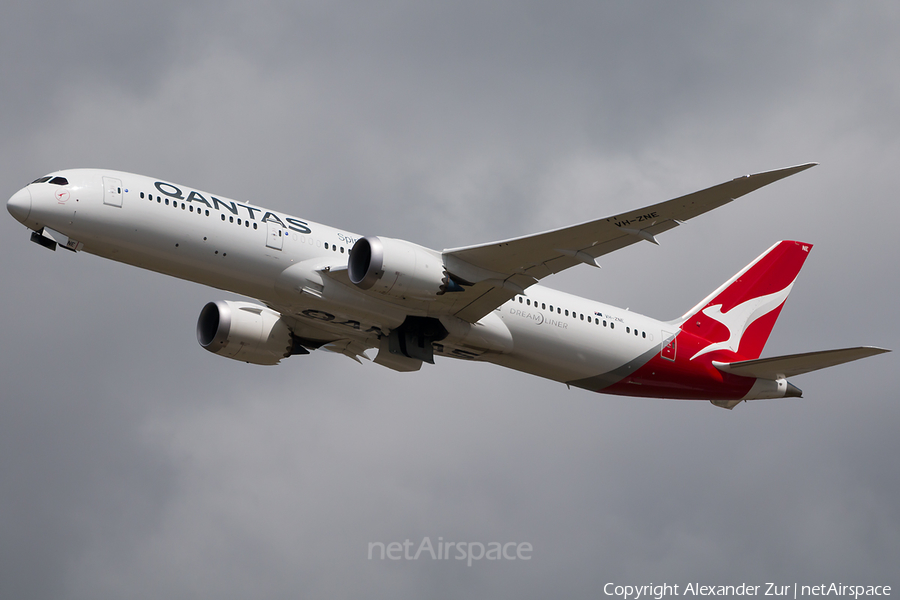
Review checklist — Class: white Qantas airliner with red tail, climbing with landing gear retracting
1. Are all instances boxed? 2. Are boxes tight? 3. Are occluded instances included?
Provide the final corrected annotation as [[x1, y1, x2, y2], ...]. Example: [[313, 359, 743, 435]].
[[7, 163, 889, 409]]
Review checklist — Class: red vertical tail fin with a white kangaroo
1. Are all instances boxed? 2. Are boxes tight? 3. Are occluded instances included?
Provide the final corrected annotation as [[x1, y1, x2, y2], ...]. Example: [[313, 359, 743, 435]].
[[676, 241, 812, 361]]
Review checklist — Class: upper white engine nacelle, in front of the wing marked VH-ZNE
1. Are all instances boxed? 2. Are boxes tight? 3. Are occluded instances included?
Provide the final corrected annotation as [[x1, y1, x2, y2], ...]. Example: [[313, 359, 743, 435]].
[[347, 236, 462, 300]]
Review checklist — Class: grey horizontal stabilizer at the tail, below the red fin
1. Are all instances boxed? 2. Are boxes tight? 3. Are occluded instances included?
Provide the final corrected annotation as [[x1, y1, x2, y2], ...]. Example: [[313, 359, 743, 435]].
[[713, 346, 890, 379]]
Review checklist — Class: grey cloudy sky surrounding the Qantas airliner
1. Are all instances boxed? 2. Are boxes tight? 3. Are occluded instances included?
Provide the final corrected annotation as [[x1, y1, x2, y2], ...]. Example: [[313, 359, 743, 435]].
[[0, 0, 900, 599]]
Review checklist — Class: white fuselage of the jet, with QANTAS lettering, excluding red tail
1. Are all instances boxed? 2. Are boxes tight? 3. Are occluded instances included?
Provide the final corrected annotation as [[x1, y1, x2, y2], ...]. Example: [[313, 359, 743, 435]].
[[10, 169, 671, 390]]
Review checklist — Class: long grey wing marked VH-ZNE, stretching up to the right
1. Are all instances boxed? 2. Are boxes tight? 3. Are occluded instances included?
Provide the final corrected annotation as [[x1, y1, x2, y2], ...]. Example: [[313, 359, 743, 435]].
[[442, 163, 817, 323]]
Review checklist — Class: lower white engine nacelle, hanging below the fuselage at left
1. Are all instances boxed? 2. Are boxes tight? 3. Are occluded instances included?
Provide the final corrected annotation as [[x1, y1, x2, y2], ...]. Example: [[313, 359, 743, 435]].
[[197, 300, 294, 365]]
